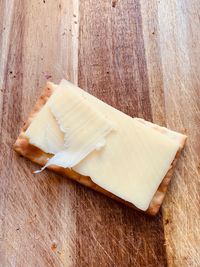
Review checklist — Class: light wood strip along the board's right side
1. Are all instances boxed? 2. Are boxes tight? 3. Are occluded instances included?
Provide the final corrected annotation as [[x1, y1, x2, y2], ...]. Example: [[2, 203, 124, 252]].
[[141, 0, 200, 266]]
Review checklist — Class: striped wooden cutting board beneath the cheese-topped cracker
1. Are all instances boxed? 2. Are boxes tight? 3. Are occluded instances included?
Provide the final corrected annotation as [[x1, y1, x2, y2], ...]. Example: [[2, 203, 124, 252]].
[[0, 0, 200, 267]]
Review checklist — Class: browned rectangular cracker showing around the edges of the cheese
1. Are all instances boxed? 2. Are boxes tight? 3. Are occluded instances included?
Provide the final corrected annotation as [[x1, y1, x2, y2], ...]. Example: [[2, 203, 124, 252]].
[[14, 83, 186, 215]]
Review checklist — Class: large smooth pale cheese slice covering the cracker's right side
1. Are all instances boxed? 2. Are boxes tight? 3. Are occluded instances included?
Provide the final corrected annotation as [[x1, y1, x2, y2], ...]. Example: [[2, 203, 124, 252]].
[[57, 80, 180, 210]]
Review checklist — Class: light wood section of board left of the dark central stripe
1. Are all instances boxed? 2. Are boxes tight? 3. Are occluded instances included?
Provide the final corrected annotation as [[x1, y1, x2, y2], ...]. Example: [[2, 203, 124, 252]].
[[0, 0, 79, 267]]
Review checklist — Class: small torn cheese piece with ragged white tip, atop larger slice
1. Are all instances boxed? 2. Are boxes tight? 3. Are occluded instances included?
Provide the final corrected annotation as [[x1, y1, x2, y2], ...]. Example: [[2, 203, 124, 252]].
[[41, 87, 113, 170]]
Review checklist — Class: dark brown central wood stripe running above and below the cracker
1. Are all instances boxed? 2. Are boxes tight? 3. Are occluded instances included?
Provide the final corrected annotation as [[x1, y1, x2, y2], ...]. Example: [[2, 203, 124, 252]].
[[77, 1, 166, 266]]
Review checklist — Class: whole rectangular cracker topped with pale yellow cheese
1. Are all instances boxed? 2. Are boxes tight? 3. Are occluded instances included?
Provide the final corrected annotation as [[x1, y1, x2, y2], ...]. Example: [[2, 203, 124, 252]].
[[14, 80, 186, 215]]
